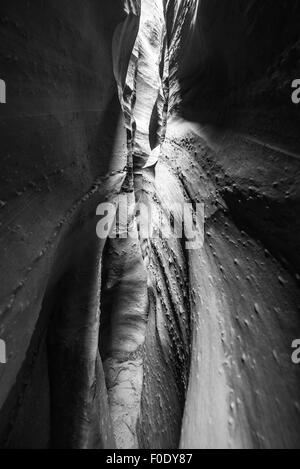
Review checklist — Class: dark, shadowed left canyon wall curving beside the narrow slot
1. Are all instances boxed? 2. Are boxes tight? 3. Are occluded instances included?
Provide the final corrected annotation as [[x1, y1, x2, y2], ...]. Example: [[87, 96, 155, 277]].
[[0, 0, 139, 447]]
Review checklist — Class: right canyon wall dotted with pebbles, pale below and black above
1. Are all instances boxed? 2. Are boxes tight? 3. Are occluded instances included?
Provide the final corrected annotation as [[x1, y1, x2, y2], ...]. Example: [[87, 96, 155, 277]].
[[160, 0, 300, 448]]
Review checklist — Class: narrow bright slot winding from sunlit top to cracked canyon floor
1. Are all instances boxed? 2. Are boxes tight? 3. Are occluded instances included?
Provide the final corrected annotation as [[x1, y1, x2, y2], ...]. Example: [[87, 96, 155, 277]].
[[100, 1, 169, 448]]
